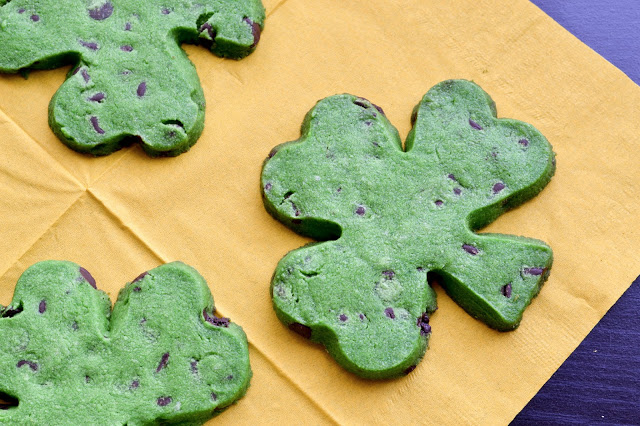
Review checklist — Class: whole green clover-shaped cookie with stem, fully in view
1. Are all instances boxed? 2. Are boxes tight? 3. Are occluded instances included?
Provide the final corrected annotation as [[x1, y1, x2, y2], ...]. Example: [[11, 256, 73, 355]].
[[262, 80, 555, 378]]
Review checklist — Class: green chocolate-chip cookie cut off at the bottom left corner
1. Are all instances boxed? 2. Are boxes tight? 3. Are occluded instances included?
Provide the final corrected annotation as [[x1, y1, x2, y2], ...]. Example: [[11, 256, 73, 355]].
[[0, 261, 251, 426]]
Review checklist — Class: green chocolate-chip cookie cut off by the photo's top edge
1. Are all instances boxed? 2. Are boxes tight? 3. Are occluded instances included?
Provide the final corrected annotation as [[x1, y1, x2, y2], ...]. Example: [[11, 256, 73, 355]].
[[0, 0, 265, 156]]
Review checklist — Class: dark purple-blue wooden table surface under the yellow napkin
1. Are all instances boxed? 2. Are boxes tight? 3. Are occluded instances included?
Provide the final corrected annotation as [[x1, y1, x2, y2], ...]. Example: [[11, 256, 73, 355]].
[[512, 0, 640, 426]]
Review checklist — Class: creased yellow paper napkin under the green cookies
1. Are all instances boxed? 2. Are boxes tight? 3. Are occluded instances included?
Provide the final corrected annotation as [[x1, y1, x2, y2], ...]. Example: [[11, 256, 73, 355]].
[[0, 0, 640, 424]]
